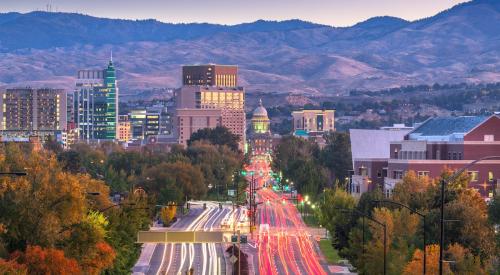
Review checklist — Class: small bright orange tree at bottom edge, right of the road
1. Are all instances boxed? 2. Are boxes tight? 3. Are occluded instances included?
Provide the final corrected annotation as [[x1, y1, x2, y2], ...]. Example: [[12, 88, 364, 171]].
[[403, 244, 452, 275]]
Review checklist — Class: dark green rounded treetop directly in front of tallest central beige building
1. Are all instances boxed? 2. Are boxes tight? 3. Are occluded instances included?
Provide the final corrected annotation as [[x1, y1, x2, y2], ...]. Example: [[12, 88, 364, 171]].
[[188, 126, 240, 152]]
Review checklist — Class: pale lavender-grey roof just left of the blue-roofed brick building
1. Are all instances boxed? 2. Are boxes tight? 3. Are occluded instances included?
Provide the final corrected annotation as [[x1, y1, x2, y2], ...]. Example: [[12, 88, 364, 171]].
[[349, 129, 410, 160]]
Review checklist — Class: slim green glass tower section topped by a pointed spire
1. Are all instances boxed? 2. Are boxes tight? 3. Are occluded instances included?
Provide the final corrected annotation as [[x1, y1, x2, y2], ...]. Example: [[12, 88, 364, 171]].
[[104, 57, 118, 139]]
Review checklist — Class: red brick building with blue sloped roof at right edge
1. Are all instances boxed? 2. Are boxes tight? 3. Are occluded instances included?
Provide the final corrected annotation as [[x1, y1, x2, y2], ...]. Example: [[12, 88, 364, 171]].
[[384, 115, 500, 198]]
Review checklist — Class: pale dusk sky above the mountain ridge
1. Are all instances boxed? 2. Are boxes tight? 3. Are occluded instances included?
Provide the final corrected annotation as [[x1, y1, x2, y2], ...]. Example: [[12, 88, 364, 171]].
[[0, 0, 467, 27]]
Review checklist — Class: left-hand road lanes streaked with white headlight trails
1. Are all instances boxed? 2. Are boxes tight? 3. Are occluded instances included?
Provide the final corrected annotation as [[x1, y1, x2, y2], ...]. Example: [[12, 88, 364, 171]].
[[134, 202, 246, 275]]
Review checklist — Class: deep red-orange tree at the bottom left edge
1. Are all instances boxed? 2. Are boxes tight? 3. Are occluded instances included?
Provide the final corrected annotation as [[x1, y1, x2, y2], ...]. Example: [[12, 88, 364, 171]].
[[13, 245, 81, 275]]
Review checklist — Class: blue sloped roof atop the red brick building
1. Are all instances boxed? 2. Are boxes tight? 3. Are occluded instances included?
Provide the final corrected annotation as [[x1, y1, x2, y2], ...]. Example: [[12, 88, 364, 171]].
[[411, 116, 488, 136]]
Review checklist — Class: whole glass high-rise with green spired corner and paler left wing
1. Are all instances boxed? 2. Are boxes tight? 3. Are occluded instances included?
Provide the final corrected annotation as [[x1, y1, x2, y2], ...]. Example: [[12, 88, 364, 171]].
[[74, 61, 118, 141]]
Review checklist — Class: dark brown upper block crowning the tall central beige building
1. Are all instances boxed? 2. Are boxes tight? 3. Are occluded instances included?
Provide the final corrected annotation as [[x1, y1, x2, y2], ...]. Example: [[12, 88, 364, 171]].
[[182, 64, 238, 87]]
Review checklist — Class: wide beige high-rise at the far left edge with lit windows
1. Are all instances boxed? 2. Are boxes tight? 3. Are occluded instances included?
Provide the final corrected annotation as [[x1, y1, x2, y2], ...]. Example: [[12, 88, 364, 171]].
[[0, 88, 67, 138]]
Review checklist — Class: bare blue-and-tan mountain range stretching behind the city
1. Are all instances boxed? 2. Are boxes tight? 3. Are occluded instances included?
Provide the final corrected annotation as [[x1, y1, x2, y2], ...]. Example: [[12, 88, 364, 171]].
[[0, 0, 500, 95]]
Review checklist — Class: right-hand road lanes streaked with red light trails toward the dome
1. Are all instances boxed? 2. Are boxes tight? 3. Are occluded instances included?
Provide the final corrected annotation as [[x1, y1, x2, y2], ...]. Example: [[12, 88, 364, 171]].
[[247, 156, 327, 275]]
